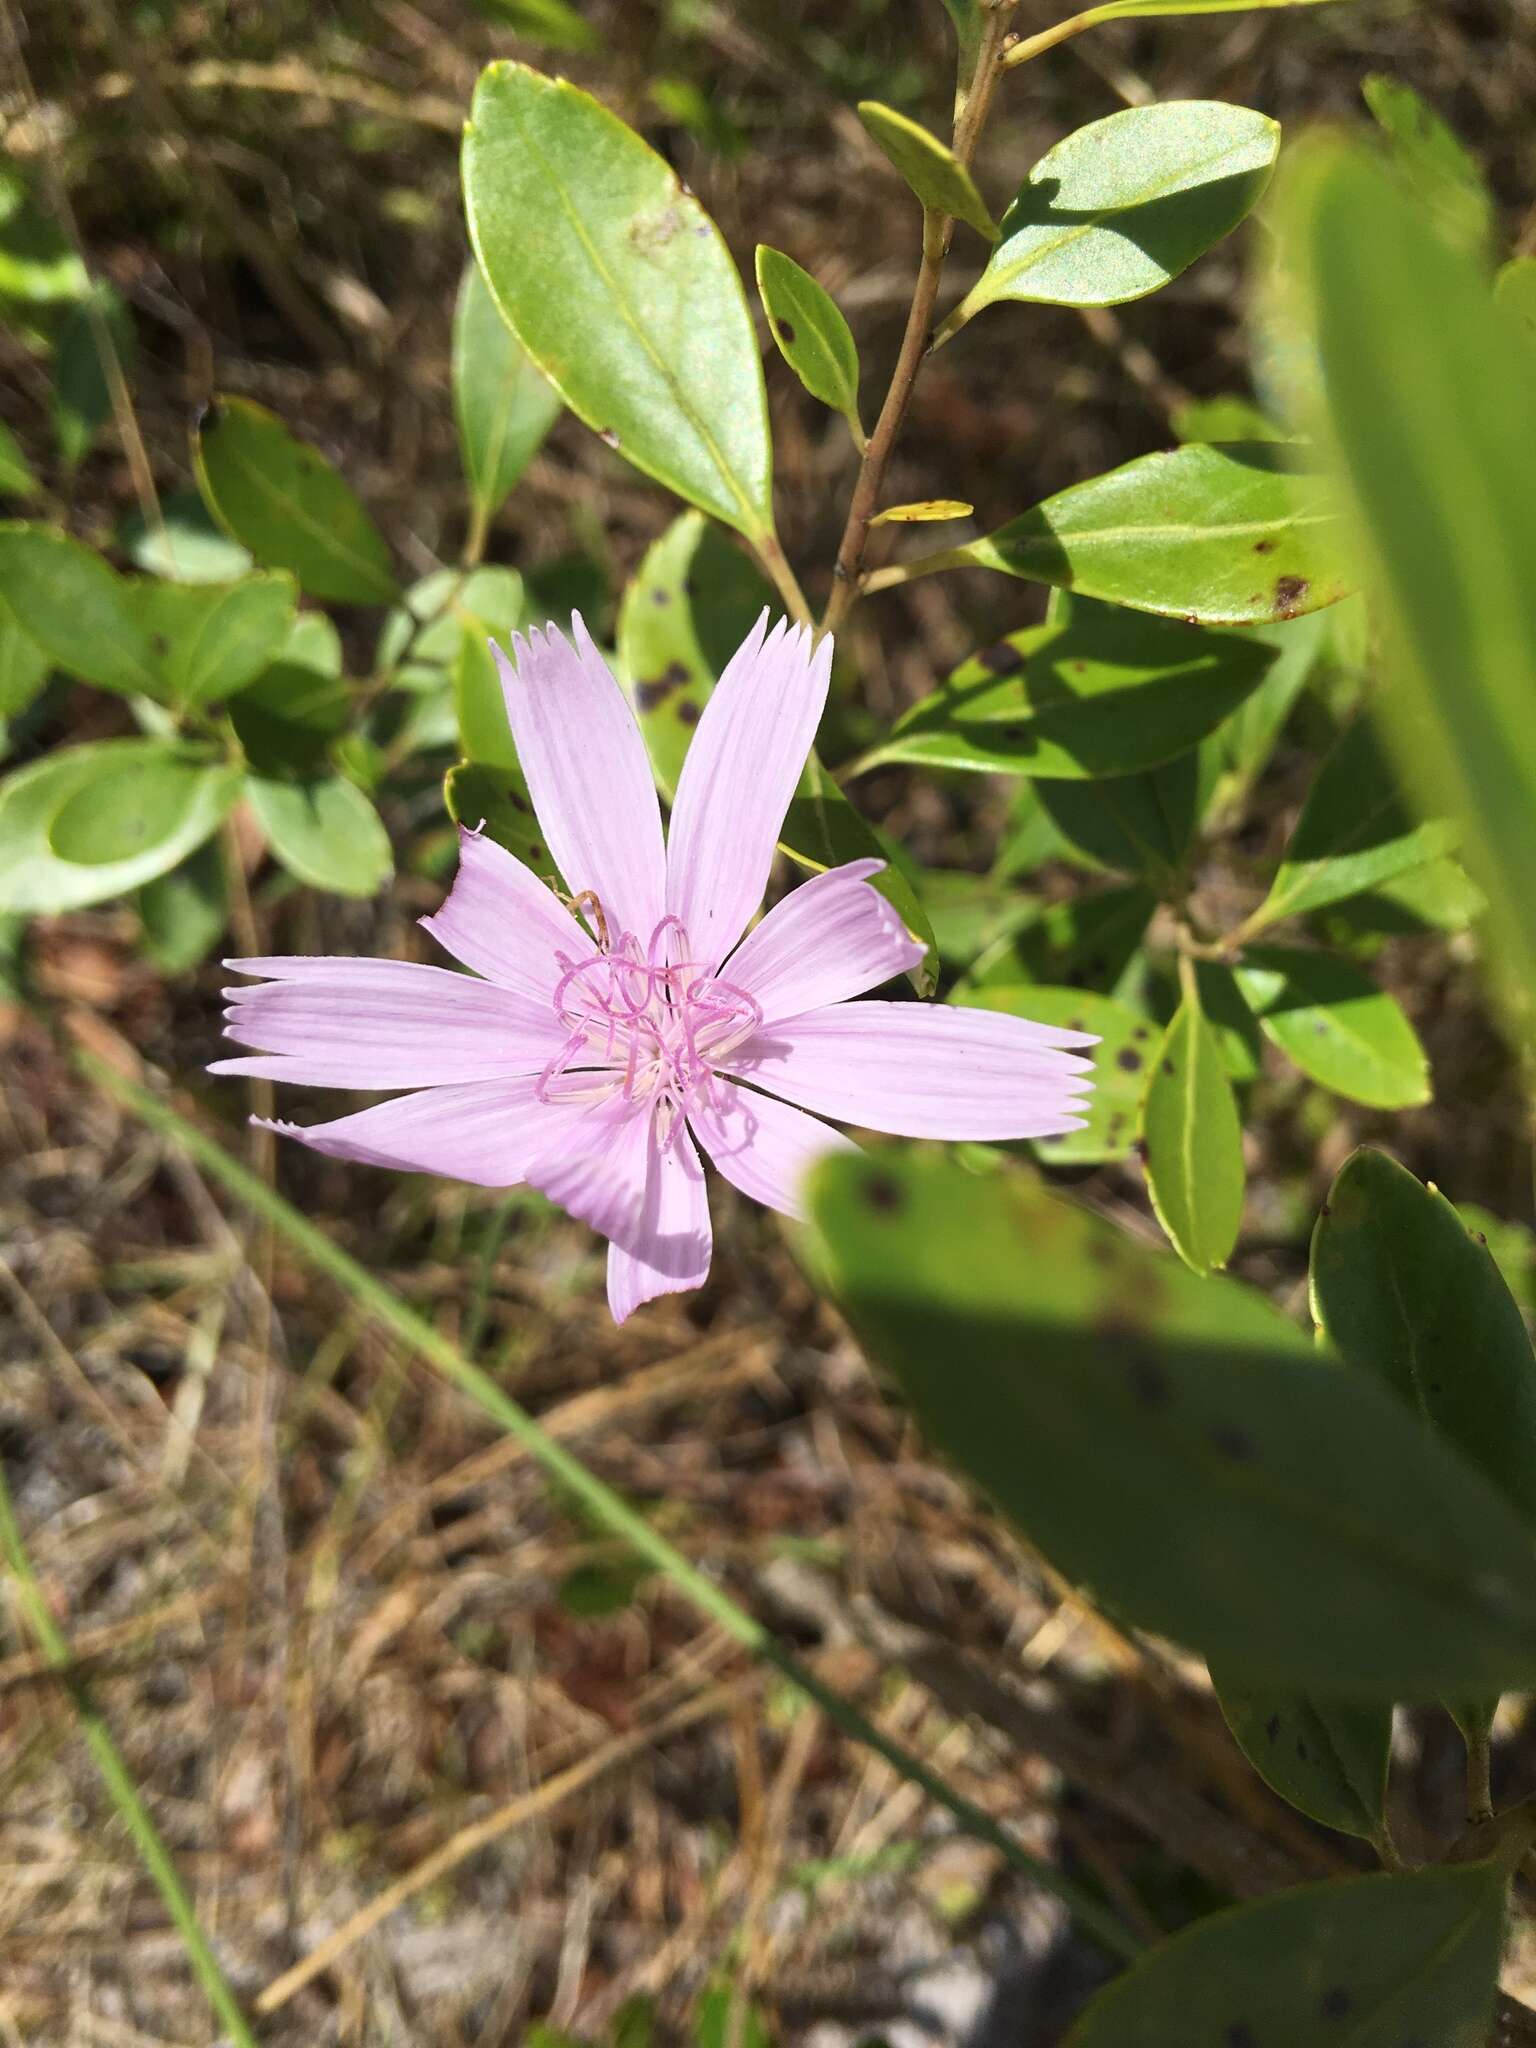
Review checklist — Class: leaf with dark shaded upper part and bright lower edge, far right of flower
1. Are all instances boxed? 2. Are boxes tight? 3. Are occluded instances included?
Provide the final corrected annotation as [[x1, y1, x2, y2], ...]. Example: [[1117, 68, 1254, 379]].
[[1247, 717, 1458, 932]]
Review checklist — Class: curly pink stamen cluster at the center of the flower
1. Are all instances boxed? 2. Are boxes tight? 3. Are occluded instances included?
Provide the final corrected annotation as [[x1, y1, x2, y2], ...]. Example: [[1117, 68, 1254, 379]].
[[539, 891, 762, 1145]]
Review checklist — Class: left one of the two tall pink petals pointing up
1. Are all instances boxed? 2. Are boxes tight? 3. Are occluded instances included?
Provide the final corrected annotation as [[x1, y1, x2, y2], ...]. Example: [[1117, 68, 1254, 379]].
[[492, 614, 666, 944]]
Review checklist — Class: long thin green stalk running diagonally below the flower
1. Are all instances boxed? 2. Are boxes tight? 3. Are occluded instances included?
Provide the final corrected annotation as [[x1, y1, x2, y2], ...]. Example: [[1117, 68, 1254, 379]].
[[74, 1047, 1141, 1960]]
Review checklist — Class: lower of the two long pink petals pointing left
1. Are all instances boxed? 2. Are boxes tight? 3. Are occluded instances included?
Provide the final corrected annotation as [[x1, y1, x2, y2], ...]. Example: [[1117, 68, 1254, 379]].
[[252, 1075, 585, 1188]]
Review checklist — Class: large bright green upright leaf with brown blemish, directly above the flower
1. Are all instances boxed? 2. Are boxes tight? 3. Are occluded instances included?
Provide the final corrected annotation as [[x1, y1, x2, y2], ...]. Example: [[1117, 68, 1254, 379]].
[[463, 63, 774, 539]]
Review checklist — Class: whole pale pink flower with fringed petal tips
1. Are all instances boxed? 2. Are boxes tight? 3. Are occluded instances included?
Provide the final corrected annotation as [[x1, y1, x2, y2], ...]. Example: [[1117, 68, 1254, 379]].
[[213, 612, 1094, 1321]]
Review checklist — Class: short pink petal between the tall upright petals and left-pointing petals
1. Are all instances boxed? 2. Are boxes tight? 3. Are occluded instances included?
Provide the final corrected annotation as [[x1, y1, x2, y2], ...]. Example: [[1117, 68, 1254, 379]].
[[418, 827, 596, 1004]]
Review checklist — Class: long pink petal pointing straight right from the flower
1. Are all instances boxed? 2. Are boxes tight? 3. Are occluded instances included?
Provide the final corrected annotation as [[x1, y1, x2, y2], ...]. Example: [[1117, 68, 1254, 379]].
[[727, 1001, 1094, 1139]]
